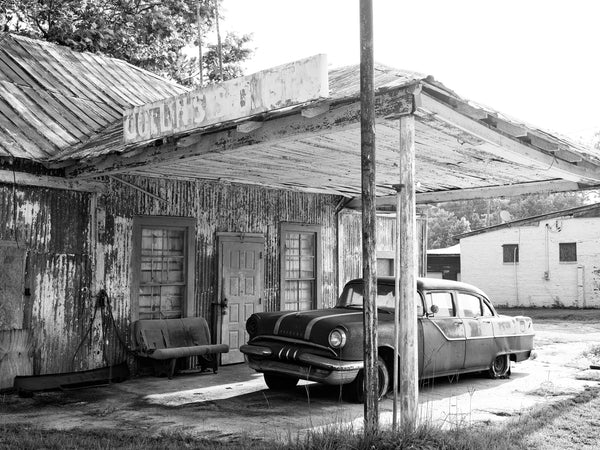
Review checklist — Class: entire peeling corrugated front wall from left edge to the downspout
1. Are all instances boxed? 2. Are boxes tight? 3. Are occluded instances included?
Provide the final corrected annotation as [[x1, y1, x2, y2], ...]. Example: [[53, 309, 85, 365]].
[[0, 176, 340, 374]]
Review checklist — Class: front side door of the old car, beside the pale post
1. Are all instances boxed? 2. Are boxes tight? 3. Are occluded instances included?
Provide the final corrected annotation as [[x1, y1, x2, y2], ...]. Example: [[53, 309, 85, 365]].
[[421, 291, 465, 378]]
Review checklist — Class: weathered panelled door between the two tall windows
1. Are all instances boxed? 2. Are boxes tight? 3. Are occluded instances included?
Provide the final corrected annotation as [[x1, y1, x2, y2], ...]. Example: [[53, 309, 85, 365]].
[[218, 233, 265, 364]]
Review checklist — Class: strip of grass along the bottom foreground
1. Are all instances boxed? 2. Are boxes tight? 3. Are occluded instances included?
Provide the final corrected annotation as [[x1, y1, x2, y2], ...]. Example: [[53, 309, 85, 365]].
[[0, 387, 600, 450]]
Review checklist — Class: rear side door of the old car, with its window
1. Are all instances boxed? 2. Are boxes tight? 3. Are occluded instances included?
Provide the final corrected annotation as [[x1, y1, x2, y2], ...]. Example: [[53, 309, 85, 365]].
[[456, 292, 496, 369]]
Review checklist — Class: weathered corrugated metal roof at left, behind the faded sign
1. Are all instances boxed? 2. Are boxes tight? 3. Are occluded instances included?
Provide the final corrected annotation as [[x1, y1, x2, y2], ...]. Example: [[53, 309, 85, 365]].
[[0, 33, 187, 161]]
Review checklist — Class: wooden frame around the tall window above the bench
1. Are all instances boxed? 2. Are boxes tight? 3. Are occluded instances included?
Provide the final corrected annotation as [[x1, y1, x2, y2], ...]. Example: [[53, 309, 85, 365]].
[[130, 216, 196, 321]]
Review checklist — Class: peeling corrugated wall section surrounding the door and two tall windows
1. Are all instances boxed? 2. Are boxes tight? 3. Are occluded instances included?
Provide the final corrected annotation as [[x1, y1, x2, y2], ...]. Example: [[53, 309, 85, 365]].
[[103, 177, 338, 318]]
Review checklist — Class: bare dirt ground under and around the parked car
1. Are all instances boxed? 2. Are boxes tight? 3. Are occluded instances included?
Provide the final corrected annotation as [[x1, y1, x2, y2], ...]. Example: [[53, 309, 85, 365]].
[[0, 320, 600, 442]]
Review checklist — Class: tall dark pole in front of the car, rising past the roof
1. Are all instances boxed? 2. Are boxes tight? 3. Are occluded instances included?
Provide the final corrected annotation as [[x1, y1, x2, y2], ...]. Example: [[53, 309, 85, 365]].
[[360, 0, 379, 435]]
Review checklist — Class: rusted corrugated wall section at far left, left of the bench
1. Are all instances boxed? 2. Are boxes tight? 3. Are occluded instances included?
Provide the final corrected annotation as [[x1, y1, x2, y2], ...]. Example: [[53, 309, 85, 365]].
[[0, 184, 99, 375]]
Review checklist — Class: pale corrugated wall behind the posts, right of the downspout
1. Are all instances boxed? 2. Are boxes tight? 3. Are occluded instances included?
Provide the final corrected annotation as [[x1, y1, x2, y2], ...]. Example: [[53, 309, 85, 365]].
[[338, 210, 426, 292]]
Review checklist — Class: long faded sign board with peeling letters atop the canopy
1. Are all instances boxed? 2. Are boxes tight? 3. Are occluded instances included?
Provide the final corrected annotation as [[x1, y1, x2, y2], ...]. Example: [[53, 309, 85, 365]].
[[123, 55, 329, 143]]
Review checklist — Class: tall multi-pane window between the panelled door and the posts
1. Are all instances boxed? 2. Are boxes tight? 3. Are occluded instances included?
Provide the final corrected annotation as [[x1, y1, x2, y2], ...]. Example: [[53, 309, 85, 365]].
[[281, 224, 321, 311]]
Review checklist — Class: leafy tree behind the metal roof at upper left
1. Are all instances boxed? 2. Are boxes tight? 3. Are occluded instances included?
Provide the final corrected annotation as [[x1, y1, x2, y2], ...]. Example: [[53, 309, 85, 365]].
[[0, 0, 251, 85]]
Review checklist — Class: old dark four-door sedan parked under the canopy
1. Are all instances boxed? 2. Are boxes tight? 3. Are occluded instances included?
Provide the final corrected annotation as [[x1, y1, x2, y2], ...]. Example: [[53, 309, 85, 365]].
[[241, 277, 534, 401]]
